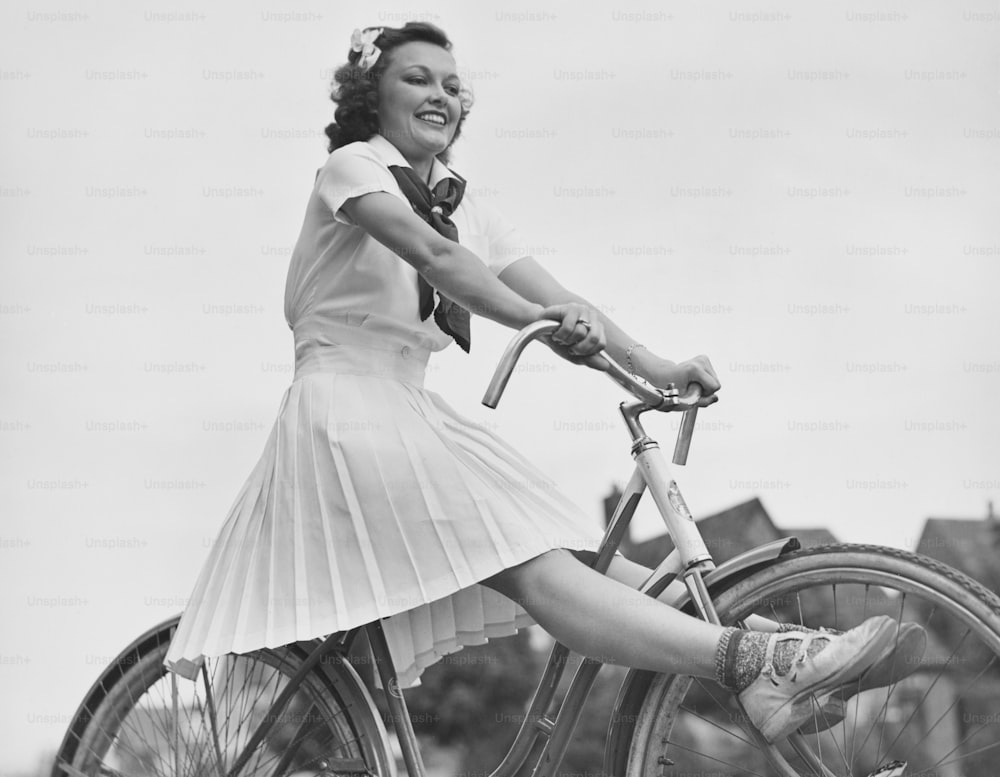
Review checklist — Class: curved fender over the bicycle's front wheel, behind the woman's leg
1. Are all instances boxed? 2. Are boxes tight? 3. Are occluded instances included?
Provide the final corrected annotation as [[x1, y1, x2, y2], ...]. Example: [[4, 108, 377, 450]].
[[604, 537, 800, 777]]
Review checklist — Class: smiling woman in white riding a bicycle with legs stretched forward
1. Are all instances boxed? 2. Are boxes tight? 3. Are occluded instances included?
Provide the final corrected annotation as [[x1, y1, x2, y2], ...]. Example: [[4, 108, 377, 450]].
[[166, 23, 896, 739]]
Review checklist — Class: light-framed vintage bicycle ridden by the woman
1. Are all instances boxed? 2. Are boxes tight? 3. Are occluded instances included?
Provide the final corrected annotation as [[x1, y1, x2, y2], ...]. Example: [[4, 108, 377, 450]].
[[52, 322, 1000, 777]]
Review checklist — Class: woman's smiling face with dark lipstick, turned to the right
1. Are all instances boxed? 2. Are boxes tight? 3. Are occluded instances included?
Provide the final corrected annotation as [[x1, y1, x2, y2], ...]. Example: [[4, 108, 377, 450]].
[[378, 41, 462, 164]]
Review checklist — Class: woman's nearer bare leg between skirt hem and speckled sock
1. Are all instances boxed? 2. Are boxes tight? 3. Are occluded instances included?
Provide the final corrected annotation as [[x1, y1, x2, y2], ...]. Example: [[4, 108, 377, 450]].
[[482, 549, 723, 678]]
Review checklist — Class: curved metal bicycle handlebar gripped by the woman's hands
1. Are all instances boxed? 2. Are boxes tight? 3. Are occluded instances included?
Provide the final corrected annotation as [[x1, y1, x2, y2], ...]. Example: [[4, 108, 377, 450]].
[[483, 321, 701, 464]]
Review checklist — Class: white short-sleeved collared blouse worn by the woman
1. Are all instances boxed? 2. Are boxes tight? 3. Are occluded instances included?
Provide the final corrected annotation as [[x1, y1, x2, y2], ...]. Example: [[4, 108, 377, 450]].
[[285, 135, 528, 351]]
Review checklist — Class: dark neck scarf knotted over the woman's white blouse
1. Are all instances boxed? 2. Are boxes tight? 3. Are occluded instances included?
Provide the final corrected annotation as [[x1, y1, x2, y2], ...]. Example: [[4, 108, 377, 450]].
[[389, 165, 471, 353]]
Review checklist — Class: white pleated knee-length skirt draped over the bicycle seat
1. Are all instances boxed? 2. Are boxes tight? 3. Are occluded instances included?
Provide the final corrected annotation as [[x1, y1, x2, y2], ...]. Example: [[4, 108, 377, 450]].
[[165, 343, 603, 687]]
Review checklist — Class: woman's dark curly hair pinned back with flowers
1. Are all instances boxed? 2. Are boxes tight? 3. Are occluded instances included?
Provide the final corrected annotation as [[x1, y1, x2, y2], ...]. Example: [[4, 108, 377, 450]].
[[326, 22, 472, 164]]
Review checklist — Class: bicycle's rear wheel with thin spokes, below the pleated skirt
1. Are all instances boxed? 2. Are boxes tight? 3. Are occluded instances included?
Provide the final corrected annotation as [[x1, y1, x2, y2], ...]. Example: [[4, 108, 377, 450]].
[[52, 618, 396, 777]]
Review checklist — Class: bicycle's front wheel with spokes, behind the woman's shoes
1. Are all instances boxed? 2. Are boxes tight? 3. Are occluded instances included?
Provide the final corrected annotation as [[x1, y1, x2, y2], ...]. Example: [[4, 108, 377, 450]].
[[626, 545, 1000, 777]]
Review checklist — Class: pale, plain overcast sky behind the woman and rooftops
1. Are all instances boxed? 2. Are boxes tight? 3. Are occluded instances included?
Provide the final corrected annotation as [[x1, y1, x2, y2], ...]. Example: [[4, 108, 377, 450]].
[[0, 0, 1000, 777]]
